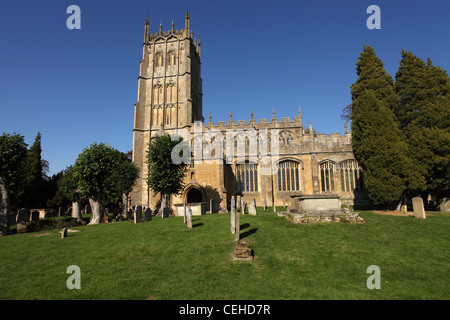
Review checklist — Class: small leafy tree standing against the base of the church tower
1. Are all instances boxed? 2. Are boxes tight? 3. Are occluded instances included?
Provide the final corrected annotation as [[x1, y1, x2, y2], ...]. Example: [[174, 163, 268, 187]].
[[146, 135, 190, 209]]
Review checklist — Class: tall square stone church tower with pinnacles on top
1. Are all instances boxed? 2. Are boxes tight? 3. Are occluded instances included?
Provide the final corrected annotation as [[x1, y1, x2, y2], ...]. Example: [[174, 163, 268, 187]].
[[131, 12, 203, 206]]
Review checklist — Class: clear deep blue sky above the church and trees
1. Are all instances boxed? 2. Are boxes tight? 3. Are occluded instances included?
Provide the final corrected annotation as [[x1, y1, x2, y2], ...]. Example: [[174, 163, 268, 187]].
[[0, 0, 450, 174]]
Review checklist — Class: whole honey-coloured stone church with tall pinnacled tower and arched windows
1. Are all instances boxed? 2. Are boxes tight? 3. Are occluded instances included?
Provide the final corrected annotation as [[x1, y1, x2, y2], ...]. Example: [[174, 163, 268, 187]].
[[129, 12, 368, 214]]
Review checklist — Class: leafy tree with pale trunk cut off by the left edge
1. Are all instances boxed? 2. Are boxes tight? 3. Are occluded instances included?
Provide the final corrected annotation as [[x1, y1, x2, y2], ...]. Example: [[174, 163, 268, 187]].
[[0, 133, 27, 235]]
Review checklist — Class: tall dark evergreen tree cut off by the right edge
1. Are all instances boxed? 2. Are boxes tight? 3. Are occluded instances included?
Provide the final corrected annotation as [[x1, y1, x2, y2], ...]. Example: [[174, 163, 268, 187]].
[[395, 50, 450, 197]]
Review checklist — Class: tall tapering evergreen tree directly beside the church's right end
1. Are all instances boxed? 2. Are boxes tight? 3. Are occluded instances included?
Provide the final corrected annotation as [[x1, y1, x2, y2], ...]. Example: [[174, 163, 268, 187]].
[[351, 46, 411, 208]]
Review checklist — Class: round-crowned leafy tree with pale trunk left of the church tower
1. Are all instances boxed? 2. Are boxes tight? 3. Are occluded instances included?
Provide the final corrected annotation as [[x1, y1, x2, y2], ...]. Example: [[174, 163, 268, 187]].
[[73, 143, 139, 224]]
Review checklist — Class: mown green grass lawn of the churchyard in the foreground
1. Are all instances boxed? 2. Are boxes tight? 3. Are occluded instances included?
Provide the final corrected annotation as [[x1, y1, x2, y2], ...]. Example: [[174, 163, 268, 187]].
[[0, 209, 450, 300]]
